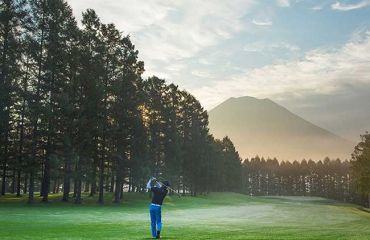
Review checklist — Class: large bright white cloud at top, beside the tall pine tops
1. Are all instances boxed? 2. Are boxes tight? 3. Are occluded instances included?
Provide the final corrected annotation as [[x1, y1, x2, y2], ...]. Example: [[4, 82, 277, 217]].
[[68, 0, 255, 76]]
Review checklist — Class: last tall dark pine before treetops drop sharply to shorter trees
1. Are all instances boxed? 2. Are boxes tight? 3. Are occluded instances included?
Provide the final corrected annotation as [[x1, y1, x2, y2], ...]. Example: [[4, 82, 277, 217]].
[[112, 31, 144, 203]]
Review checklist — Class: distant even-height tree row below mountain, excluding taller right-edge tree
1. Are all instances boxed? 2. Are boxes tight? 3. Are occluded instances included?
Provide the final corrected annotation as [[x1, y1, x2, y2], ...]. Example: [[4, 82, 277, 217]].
[[243, 156, 353, 201]]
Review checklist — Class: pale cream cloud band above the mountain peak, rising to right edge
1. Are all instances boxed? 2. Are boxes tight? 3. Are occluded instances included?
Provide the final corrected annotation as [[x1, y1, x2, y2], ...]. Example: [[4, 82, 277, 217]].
[[190, 32, 370, 109]]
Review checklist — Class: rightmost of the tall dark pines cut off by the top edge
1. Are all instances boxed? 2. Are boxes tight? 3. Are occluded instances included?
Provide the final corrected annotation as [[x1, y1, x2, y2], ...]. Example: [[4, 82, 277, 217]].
[[41, 0, 76, 202]]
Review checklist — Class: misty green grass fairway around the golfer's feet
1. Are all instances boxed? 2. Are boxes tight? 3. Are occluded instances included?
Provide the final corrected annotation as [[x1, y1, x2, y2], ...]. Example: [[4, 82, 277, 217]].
[[0, 193, 370, 240]]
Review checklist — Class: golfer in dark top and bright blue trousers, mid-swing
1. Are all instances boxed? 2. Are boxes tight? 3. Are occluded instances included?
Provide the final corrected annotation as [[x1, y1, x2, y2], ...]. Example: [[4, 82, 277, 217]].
[[147, 177, 170, 239]]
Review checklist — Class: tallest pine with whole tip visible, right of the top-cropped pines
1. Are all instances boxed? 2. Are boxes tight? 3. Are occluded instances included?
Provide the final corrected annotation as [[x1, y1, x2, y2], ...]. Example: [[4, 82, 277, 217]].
[[74, 9, 104, 203]]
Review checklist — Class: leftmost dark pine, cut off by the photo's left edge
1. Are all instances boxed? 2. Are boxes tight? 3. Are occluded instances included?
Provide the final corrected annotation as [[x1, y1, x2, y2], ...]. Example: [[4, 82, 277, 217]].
[[0, 0, 27, 195]]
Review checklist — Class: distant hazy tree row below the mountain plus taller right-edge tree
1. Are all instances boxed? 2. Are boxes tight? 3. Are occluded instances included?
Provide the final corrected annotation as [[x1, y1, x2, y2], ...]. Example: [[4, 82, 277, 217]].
[[241, 133, 370, 207]]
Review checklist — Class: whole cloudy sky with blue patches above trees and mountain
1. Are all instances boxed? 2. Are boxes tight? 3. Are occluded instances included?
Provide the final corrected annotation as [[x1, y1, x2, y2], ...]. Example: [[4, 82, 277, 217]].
[[68, 0, 370, 141]]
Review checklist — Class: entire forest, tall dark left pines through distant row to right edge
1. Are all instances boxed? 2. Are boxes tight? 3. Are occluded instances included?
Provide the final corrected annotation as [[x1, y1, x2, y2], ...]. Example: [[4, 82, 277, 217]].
[[0, 0, 370, 205]]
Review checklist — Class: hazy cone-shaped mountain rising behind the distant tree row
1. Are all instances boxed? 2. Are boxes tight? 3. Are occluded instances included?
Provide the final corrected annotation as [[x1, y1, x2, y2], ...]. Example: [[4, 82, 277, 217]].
[[208, 97, 355, 160]]
